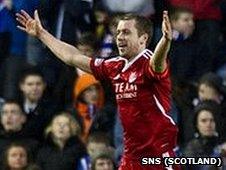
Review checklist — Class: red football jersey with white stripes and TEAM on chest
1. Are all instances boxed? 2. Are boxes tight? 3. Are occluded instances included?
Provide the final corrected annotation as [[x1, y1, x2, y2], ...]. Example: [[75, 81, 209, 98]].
[[90, 49, 177, 159]]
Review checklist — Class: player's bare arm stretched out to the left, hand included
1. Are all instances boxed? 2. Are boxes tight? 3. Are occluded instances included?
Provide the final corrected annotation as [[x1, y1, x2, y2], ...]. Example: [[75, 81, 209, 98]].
[[16, 10, 91, 73]]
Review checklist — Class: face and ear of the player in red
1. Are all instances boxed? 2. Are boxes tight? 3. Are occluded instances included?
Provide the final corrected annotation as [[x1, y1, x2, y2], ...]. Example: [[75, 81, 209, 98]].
[[116, 20, 147, 59]]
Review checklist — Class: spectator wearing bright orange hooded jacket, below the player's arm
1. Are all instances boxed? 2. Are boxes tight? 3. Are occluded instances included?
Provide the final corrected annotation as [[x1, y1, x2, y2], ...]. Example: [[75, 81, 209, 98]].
[[74, 74, 104, 141]]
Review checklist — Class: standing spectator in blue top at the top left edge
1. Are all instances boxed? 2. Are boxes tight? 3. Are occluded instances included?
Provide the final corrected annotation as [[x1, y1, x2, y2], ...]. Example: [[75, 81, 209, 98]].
[[0, 0, 39, 98]]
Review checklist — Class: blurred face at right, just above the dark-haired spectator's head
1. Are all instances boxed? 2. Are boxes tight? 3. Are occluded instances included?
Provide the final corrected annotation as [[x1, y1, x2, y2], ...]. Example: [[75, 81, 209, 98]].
[[198, 84, 220, 103]]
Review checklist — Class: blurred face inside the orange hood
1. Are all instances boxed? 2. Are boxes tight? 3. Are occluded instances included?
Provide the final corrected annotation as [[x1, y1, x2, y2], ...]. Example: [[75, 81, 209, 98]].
[[82, 85, 99, 104]]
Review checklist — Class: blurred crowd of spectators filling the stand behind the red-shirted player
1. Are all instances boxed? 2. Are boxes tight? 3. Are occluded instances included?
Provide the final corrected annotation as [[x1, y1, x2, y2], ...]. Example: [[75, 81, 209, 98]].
[[0, 0, 226, 170]]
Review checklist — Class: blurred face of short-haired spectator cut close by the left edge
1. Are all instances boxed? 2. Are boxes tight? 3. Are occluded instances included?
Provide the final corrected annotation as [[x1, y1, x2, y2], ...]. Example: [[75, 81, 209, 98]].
[[1, 103, 26, 131]]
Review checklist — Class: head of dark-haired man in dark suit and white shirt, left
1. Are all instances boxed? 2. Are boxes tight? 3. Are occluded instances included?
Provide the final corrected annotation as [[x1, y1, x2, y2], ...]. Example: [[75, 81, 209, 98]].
[[20, 75, 46, 103]]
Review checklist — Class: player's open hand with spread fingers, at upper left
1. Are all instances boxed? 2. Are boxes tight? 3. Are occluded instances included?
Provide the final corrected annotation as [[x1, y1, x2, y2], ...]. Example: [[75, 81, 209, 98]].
[[16, 10, 43, 37]]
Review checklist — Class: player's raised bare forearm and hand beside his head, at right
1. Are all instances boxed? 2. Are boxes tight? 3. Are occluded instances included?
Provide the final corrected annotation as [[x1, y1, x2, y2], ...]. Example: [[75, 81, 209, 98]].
[[150, 11, 172, 73]]
